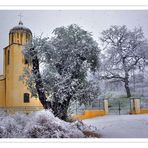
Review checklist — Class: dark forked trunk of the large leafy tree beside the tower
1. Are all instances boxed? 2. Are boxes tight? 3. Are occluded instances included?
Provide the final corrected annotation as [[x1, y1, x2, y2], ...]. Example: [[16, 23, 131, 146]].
[[30, 48, 72, 120]]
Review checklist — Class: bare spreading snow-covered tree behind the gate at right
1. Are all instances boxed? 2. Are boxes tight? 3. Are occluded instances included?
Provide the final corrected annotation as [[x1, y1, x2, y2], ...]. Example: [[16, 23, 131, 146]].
[[100, 26, 146, 97]]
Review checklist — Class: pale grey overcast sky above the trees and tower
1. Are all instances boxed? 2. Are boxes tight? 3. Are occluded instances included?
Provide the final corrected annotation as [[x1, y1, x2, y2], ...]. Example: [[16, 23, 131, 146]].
[[0, 10, 148, 74]]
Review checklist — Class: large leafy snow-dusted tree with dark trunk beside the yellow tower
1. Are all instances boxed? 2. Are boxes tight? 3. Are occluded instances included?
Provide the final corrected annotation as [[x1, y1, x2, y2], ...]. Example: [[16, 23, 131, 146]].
[[23, 25, 100, 120]]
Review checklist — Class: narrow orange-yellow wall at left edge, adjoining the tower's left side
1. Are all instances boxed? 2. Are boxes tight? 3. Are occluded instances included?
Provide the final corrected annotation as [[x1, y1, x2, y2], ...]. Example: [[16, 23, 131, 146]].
[[0, 78, 5, 107]]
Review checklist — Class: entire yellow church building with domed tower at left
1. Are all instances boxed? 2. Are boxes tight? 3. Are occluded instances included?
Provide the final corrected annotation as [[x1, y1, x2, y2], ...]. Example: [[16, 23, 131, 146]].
[[0, 21, 42, 111]]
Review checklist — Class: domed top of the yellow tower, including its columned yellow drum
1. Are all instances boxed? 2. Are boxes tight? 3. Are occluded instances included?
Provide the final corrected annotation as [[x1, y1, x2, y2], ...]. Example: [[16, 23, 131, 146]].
[[9, 20, 32, 45]]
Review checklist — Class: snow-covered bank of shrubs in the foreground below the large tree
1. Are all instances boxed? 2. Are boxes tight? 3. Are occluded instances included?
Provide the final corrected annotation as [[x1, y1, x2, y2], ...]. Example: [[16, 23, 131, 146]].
[[0, 110, 100, 138]]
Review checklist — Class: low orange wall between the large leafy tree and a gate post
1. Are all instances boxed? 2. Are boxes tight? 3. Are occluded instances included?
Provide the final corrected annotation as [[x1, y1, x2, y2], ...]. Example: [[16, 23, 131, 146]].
[[72, 110, 106, 120]]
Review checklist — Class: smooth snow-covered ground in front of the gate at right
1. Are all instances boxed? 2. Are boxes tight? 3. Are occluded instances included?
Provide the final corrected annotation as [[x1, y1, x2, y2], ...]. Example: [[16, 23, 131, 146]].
[[83, 114, 148, 138]]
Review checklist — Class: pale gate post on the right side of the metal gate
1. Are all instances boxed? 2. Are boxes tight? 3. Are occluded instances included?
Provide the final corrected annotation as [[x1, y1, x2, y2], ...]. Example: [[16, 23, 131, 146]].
[[131, 98, 141, 114]]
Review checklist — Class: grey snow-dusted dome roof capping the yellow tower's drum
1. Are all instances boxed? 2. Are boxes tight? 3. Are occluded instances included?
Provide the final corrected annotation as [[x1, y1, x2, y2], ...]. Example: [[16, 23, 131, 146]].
[[9, 21, 32, 34]]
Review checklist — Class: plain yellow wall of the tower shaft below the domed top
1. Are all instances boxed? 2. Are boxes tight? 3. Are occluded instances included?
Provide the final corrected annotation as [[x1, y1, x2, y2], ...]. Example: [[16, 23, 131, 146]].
[[5, 44, 41, 107]]
